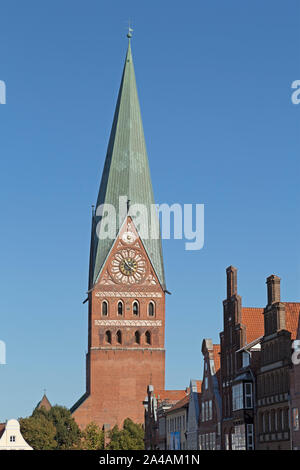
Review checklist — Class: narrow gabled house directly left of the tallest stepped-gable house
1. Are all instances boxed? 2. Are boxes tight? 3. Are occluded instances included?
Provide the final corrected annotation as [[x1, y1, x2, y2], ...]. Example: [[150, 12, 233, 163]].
[[198, 338, 222, 450]]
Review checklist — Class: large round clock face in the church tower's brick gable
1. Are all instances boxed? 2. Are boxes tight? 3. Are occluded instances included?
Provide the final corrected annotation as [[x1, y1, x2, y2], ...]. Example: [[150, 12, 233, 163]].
[[110, 249, 147, 284]]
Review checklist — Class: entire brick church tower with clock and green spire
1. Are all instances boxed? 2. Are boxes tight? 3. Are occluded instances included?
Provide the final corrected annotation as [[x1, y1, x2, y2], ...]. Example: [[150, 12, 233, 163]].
[[71, 33, 166, 429]]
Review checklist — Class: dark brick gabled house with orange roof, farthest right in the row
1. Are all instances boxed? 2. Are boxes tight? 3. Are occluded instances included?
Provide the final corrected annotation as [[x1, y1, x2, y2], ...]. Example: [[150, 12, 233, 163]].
[[256, 275, 300, 450]]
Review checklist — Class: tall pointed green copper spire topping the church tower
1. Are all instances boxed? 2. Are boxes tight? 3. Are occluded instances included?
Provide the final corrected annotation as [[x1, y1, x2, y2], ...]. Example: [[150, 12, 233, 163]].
[[90, 36, 165, 288]]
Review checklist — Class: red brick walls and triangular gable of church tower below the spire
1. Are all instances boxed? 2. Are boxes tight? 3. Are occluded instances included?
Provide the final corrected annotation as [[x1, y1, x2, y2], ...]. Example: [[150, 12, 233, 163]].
[[72, 217, 165, 429]]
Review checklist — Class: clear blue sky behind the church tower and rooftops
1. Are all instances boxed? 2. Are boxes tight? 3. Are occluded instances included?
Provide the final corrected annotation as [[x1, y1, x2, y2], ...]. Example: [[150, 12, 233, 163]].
[[0, 0, 300, 420]]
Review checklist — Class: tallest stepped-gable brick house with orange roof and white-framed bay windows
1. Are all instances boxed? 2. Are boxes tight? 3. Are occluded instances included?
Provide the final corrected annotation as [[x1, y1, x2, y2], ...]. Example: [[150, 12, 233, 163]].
[[220, 266, 264, 450]]
